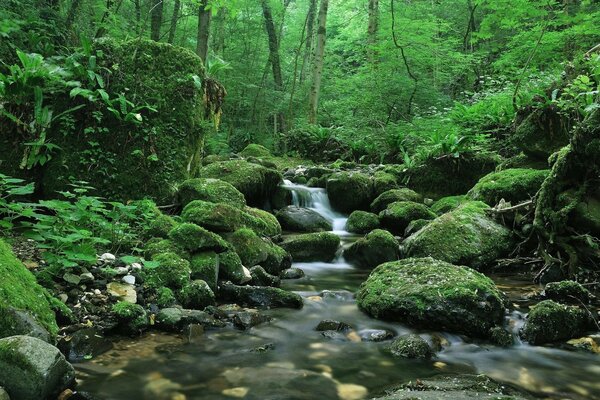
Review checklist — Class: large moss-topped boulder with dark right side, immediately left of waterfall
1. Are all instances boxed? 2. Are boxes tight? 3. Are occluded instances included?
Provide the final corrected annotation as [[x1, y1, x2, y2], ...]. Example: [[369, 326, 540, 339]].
[[198, 160, 283, 207]]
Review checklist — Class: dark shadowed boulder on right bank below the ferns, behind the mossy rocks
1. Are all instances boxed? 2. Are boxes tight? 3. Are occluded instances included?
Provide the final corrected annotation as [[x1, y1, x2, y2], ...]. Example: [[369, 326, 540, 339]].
[[402, 152, 502, 199]]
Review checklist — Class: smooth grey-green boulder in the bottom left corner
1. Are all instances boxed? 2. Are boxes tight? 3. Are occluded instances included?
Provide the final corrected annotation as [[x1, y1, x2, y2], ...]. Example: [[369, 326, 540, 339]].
[[0, 336, 75, 400]]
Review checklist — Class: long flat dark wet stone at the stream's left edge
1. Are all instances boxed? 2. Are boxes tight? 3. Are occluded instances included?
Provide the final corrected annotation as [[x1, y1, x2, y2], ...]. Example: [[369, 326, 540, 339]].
[[219, 282, 304, 308]]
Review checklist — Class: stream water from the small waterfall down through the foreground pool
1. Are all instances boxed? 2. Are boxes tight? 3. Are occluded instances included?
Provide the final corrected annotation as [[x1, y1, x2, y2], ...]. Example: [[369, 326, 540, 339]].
[[77, 183, 600, 400]]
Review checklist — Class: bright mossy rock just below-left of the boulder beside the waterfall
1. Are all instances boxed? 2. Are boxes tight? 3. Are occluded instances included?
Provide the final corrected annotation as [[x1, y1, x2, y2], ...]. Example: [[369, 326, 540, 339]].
[[177, 178, 246, 209]]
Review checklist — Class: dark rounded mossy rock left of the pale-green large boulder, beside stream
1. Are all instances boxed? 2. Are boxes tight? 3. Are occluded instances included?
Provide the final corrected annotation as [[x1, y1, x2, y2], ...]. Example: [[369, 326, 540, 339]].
[[344, 229, 400, 269]]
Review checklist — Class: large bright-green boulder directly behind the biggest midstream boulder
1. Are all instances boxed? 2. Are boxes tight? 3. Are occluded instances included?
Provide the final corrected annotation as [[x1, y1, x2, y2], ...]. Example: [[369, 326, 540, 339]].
[[403, 202, 513, 269]]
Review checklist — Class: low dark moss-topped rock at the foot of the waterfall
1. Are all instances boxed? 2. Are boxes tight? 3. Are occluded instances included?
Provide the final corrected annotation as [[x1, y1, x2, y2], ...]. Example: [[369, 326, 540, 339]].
[[281, 232, 340, 262]]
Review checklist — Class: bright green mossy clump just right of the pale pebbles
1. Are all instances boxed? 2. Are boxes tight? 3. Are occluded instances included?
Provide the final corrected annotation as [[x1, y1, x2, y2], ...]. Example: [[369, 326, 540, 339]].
[[145, 253, 191, 289]]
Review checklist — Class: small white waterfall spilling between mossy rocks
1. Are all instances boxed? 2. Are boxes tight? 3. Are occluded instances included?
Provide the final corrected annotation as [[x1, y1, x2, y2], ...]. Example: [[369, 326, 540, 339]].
[[283, 180, 348, 234]]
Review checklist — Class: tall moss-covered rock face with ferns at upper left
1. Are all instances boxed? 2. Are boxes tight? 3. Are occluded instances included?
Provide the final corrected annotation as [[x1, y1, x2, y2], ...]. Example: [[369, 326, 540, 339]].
[[0, 39, 205, 202]]
